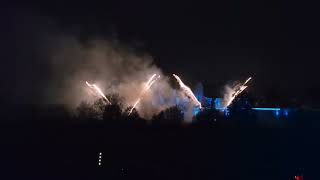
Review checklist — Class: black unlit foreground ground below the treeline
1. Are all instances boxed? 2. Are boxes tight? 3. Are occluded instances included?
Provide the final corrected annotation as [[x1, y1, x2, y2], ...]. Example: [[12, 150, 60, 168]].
[[0, 125, 320, 180]]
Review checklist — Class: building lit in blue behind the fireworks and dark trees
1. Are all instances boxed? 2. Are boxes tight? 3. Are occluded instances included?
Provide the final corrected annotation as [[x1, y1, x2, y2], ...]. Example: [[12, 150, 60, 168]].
[[153, 87, 290, 124]]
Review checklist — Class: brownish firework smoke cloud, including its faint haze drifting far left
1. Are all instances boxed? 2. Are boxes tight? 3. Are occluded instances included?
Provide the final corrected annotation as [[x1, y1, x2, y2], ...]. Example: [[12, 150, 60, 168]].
[[2, 14, 200, 119]]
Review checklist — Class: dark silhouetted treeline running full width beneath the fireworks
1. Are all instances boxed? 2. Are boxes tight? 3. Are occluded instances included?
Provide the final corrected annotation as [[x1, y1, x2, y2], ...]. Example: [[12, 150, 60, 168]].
[[0, 94, 320, 127]]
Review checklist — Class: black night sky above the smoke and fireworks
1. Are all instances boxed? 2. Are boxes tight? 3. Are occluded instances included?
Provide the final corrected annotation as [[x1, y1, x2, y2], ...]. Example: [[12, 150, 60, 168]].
[[1, 0, 320, 106]]
